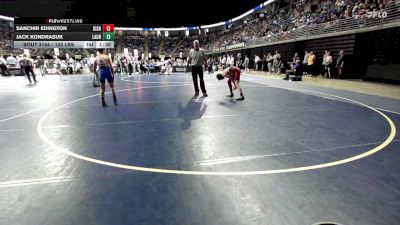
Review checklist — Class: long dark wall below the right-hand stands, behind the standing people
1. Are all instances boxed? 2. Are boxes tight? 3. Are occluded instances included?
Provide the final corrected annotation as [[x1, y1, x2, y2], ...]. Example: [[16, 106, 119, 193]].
[[211, 28, 400, 83]]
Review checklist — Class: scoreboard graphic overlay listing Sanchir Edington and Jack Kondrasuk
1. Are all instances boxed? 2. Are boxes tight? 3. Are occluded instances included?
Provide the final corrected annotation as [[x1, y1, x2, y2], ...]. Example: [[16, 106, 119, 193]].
[[14, 18, 115, 49]]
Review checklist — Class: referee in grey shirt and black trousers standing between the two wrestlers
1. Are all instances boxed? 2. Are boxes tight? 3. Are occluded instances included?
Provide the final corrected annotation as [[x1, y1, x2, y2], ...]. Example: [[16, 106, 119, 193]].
[[187, 40, 208, 97]]
